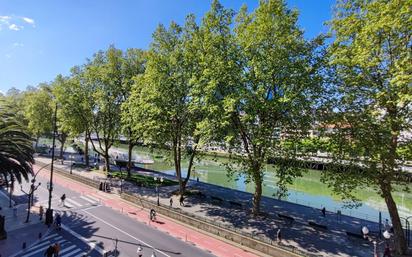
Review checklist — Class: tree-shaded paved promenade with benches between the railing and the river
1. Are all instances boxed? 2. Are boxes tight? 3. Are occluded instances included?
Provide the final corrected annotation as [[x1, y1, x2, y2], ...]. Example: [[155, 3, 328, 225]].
[[34, 155, 408, 257]]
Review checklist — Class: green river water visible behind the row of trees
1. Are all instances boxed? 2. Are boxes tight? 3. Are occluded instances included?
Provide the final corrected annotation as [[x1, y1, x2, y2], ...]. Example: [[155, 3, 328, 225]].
[[38, 139, 412, 222]]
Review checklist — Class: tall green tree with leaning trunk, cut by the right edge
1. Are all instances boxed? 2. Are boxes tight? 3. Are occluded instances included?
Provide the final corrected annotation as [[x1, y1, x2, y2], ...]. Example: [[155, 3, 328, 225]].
[[325, 0, 412, 254]]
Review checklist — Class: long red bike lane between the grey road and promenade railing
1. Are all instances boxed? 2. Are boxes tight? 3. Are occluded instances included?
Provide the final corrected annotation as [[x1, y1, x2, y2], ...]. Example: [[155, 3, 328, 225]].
[[34, 165, 259, 257]]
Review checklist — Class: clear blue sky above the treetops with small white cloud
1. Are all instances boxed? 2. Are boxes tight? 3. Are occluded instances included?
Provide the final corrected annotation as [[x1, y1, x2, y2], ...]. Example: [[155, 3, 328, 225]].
[[0, 0, 335, 93]]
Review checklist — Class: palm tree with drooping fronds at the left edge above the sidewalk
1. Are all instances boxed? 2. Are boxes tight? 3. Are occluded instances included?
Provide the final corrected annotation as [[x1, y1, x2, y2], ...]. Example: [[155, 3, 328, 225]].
[[0, 102, 34, 195]]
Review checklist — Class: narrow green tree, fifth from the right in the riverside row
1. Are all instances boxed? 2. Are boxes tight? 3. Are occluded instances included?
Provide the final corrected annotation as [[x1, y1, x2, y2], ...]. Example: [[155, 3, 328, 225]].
[[84, 46, 124, 172]]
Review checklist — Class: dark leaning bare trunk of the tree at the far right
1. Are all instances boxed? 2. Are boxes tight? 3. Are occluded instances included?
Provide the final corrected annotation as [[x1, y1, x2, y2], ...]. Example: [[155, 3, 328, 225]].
[[380, 183, 408, 254]]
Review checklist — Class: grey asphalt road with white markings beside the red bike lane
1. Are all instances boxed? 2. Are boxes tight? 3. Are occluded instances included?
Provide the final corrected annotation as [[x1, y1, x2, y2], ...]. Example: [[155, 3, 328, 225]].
[[18, 170, 214, 257]]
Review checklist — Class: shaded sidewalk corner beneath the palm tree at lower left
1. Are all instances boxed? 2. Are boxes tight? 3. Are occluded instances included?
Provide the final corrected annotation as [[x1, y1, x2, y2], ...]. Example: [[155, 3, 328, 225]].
[[0, 186, 48, 257]]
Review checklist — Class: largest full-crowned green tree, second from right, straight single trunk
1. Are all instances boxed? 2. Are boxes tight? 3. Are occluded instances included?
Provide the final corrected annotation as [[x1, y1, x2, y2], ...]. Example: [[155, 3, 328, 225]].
[[199, 0, 321, 215]]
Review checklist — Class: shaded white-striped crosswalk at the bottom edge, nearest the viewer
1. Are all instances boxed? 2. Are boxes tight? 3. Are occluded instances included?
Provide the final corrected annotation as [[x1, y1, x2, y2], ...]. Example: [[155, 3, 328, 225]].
[[17, 232, 88, 257]]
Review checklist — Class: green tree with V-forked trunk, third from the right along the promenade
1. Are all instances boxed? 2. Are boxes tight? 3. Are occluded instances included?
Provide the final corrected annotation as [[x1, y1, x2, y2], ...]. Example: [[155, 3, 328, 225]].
[[127, 16, 201, 194]]
